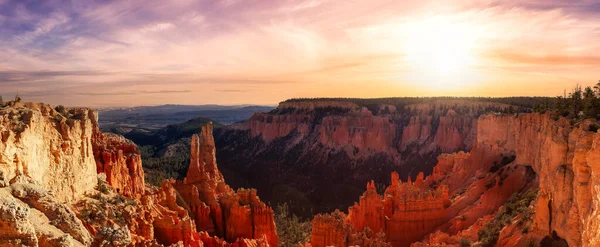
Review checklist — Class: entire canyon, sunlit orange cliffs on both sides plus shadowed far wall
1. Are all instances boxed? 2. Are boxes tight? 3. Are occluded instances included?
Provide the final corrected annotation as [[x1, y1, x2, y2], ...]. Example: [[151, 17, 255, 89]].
[[0, 99, 600, 247]]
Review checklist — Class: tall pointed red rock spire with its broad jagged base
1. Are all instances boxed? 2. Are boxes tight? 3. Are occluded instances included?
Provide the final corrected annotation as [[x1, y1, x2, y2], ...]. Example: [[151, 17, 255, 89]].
[[174, 123, 278, 246]]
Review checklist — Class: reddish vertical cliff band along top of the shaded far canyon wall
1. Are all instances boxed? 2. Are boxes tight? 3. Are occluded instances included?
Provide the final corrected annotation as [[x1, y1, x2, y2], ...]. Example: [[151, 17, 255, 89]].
[[240, 100, 507, 153]]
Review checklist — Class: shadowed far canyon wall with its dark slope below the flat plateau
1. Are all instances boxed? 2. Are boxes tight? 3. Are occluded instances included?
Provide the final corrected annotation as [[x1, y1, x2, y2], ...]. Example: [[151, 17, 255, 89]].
[[215, 98, 509, 217]]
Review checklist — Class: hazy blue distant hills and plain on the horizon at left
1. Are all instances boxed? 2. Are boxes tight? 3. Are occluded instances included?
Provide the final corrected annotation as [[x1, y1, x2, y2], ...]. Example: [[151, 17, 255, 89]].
[[98, 105, 275, 133]]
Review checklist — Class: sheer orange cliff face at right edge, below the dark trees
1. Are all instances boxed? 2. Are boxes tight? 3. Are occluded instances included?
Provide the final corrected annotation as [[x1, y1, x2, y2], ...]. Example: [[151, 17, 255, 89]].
[[478, 114, 600, 246]]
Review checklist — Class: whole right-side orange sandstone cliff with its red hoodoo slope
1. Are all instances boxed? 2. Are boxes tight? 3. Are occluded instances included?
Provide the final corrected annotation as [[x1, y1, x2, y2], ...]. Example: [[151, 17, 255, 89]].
[[311, 114, 600, 246]]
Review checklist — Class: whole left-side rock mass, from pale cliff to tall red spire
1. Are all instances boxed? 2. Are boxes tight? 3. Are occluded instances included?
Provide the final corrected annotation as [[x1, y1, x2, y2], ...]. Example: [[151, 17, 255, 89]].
[[0, 101, 278, 247]]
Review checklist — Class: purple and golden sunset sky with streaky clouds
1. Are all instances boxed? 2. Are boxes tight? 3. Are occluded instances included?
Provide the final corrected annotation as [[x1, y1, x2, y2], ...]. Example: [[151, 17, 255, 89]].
[[0, 0, 600, 107]]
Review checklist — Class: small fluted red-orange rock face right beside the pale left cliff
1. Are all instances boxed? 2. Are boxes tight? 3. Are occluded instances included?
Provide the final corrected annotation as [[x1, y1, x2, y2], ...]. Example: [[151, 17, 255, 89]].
[[92, 131, 145, 197]]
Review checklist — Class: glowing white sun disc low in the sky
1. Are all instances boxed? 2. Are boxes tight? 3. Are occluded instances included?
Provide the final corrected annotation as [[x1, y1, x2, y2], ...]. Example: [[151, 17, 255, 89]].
[[402, 18, 480, 88]]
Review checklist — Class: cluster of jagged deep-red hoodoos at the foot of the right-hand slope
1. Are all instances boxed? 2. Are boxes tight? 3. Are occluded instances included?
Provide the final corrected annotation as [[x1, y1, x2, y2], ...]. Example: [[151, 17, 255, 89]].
[[311, 173, 450, 247]]
